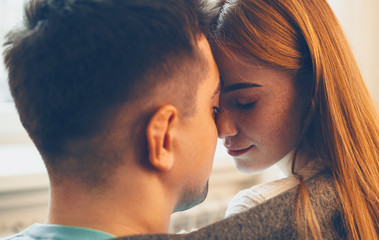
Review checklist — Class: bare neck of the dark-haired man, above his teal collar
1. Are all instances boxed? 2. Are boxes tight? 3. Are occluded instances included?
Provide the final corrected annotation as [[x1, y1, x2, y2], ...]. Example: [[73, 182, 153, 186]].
[[45, 171, 175, 236]]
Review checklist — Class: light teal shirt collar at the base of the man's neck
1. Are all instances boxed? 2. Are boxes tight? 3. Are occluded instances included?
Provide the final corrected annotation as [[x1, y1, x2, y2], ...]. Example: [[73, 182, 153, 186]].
[[2, 223, 115, 240]]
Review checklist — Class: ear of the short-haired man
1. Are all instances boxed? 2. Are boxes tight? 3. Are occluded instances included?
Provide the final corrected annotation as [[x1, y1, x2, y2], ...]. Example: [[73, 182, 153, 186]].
[[146, 105, 178, 171]]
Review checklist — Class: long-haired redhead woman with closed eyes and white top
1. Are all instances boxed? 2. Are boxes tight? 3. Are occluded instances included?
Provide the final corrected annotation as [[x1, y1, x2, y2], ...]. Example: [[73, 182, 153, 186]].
[[210, 0, 379, 239]]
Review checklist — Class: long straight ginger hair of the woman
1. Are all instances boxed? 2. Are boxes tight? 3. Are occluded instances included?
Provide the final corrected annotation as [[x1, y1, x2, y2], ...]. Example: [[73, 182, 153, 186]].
[[210, 0, 379, 239]]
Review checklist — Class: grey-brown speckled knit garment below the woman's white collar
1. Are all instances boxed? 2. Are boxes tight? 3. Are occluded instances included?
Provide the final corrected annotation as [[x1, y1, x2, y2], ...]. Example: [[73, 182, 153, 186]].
[[113, 171, 346, 240]]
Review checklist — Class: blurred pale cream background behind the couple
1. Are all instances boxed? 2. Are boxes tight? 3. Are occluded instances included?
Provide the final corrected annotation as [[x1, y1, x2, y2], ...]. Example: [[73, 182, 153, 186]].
[[0, 0, 379, 237]]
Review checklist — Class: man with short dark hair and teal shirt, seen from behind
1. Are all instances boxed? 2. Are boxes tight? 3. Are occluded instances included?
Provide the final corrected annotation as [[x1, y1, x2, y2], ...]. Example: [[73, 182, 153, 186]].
[[4, 0, 219, 239]]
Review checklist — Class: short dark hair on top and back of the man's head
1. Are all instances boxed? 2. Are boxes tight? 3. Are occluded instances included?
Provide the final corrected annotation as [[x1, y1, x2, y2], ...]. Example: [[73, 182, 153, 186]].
[[4, 0, 211, 182]]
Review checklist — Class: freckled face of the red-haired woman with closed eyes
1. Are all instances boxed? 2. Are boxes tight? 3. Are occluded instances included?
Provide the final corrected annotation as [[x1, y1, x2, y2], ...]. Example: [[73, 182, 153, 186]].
[[215, 51, 304, 173]]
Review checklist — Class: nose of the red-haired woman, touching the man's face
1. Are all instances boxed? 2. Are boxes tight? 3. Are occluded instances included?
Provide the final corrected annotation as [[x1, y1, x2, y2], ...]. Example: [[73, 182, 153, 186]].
[[217, 108, 238, 139]]
